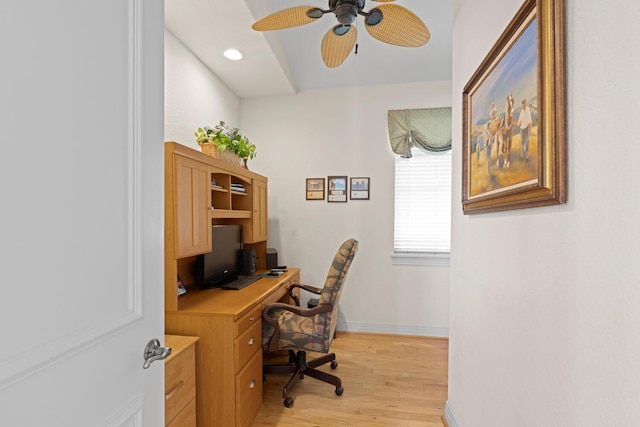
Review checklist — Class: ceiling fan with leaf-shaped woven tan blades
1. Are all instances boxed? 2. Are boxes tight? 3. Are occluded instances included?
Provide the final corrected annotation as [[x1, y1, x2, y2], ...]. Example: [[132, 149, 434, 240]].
[[251, 0, 431, 68]]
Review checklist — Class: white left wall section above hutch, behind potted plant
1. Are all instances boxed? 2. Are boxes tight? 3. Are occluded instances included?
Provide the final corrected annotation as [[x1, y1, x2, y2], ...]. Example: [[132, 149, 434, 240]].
[[164, 29, 240, 145]]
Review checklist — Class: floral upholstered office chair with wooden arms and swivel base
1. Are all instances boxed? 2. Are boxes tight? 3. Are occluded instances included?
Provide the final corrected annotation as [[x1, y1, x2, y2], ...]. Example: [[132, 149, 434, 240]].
[[262, 239, 358, 408]]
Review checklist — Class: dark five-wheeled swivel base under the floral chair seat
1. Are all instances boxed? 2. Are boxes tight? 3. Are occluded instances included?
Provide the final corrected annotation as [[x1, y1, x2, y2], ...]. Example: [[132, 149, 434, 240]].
[[263, 350, 344, 408]]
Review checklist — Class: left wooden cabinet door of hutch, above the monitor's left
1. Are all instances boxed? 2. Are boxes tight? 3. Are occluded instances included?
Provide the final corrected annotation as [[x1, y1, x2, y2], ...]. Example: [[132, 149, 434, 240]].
[[174, 155, 211, 258]]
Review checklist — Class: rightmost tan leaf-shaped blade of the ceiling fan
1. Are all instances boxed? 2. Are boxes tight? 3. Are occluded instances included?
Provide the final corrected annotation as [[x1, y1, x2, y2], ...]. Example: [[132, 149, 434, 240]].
[[365, 4, 431, 47]]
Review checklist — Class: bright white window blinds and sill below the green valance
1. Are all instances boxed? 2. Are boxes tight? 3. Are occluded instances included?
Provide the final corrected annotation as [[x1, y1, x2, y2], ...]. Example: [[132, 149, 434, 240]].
[[392, 147, 451, 265]]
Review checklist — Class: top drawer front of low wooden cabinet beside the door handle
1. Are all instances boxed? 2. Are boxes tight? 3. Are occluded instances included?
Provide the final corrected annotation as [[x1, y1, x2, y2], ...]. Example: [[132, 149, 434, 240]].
[[164, 345, 196, 421]]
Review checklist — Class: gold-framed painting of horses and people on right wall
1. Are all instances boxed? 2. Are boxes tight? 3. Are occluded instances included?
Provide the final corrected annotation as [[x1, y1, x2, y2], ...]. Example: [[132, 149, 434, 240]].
[[462, 0, 566, 214]]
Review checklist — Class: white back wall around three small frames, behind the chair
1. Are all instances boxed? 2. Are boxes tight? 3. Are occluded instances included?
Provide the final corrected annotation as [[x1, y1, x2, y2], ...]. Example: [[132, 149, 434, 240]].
[[241, 82, 451, 336]]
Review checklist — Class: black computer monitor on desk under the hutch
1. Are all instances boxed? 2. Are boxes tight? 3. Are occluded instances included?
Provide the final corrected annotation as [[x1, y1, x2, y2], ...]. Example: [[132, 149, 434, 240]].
[[194, 225, 242, 288]]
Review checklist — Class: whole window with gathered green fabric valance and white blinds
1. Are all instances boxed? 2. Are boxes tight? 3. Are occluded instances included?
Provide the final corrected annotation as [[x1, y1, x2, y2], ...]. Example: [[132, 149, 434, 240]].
[[387, 107, 451, 265]]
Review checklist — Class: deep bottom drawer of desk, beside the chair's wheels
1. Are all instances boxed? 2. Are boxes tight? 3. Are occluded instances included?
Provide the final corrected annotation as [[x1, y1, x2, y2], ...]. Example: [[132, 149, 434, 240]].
[[236, 352, 262, 427]]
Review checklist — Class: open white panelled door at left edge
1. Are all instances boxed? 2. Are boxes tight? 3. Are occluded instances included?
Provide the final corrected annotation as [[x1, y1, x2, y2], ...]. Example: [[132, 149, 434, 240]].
[[0, 0, 164, 427]]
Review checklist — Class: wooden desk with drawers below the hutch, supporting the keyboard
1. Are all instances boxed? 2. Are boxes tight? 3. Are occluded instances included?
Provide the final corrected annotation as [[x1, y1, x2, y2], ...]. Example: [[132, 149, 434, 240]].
[[165, 268, 300, 427]]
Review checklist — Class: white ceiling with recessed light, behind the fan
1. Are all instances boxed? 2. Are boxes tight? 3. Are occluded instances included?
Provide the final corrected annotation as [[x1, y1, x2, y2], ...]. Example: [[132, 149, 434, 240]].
[[165, 0, 453, 98]]
